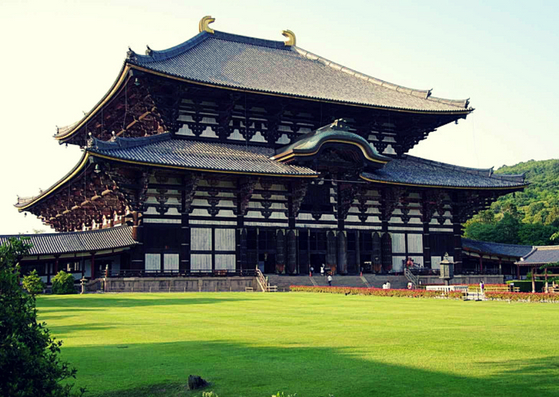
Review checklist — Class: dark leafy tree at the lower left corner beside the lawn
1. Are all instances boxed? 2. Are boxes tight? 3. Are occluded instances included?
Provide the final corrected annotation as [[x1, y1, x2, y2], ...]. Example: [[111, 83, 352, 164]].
[[0, 238, 84, 397]]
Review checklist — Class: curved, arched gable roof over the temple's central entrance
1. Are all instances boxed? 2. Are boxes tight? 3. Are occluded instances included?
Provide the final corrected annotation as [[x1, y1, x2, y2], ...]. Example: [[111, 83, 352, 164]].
[[272, 119, 391, 168]]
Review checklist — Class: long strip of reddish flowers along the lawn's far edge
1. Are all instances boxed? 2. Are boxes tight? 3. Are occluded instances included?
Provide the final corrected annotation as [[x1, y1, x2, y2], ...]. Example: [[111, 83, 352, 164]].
[[289, 285, 462, 299]]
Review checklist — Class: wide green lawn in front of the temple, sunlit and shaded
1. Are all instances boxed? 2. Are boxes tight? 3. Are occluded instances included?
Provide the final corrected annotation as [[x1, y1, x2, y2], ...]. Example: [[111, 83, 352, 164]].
[[37, 293, 559, 397]]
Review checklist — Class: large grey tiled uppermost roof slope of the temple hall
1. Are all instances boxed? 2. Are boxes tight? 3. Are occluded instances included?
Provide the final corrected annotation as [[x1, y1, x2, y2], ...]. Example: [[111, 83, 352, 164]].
[[127, 31, 471, 113]]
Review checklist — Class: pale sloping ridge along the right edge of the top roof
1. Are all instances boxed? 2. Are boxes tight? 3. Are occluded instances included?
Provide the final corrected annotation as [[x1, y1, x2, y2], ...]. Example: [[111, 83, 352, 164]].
[[292, 46, 470, 109]]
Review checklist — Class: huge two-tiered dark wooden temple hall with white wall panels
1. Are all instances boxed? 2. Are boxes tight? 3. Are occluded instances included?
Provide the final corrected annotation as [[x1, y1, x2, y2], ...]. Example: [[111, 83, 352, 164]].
[[16, 17, 526, 277]]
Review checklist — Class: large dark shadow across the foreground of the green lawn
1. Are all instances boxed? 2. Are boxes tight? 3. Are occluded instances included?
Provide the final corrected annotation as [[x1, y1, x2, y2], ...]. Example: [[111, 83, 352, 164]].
[[64, 342, 559, 397]]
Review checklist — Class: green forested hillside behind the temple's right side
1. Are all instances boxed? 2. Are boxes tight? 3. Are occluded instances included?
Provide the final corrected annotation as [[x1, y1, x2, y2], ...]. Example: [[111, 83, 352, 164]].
[[464, 160, 559, 245]]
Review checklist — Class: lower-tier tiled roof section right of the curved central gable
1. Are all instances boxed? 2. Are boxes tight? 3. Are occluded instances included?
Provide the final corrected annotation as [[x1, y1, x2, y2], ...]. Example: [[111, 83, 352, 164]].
[[362, 156, 527, 189]]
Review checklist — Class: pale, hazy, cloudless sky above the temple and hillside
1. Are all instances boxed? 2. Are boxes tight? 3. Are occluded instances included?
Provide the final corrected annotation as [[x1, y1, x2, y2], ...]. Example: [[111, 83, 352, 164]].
[[0, 0, 559, 234]]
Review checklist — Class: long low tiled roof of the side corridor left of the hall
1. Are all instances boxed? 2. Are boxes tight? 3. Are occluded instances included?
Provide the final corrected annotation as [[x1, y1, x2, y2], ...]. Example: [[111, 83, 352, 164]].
[[0, 226, 137, 255]]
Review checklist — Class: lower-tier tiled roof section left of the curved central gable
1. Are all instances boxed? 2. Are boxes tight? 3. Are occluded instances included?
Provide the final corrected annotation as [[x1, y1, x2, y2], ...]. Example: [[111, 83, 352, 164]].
[[92, 133, 317, 176]]
